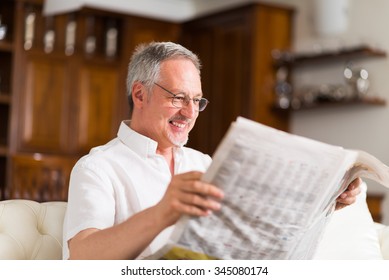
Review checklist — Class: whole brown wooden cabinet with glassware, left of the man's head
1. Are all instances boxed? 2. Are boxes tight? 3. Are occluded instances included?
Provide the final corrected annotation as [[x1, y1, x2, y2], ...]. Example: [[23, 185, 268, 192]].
[[0, 0, 179, 201]]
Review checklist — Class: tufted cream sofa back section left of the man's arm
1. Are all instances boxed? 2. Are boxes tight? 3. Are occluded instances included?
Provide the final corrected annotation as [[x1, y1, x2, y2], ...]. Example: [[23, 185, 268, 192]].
[[0, 199, 66, 260]]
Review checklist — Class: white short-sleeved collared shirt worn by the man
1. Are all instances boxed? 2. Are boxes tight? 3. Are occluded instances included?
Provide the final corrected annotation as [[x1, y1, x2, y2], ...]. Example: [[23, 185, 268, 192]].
[[63, 121, 211, 259]]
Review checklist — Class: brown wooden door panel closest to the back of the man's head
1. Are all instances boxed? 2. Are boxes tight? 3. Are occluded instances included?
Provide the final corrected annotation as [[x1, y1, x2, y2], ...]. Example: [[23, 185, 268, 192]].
[[78, 64, 118, 153]]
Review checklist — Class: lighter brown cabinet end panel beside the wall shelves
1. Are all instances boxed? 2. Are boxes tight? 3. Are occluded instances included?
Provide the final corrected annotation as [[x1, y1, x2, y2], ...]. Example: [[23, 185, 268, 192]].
[[250, 6, 293, 131]]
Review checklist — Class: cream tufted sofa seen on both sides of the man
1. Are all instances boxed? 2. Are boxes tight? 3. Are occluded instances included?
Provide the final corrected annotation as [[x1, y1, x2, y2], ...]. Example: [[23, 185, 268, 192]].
[[0, 196, 389, 260]]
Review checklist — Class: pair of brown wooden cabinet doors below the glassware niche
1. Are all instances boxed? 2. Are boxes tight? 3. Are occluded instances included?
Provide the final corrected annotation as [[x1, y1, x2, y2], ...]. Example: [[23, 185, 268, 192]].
[[16, 55, 120, 154]]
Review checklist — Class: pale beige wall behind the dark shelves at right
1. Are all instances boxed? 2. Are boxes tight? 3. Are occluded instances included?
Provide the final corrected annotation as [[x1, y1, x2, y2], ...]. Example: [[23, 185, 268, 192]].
[[260, 0, 389, 224]]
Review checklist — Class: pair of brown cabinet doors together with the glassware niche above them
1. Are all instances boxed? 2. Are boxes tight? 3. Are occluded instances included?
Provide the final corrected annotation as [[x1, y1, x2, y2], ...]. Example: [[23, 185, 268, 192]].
[[13, 3, 125, 155]]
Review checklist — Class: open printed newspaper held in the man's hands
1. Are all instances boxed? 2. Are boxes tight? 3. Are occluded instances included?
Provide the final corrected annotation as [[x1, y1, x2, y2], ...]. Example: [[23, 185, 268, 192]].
[[149, 117, 389, 260]]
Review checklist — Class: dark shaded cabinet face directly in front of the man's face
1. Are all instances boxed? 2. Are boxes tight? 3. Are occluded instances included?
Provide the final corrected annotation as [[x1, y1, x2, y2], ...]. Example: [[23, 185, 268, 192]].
[[183, 9, 252, 154]]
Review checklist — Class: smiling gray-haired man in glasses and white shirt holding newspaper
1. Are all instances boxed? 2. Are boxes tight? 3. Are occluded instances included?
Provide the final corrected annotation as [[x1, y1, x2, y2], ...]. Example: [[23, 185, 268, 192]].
[[64, 42, 360, 259]]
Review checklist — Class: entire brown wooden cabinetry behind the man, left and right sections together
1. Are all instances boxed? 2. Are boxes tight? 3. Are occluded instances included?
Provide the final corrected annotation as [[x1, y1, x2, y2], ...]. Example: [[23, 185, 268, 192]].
[[0, 0, 293, 201]]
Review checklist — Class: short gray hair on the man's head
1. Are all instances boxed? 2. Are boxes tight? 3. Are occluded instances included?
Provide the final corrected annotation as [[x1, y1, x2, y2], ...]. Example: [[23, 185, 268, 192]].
[[127, 42, 201, 111]]
